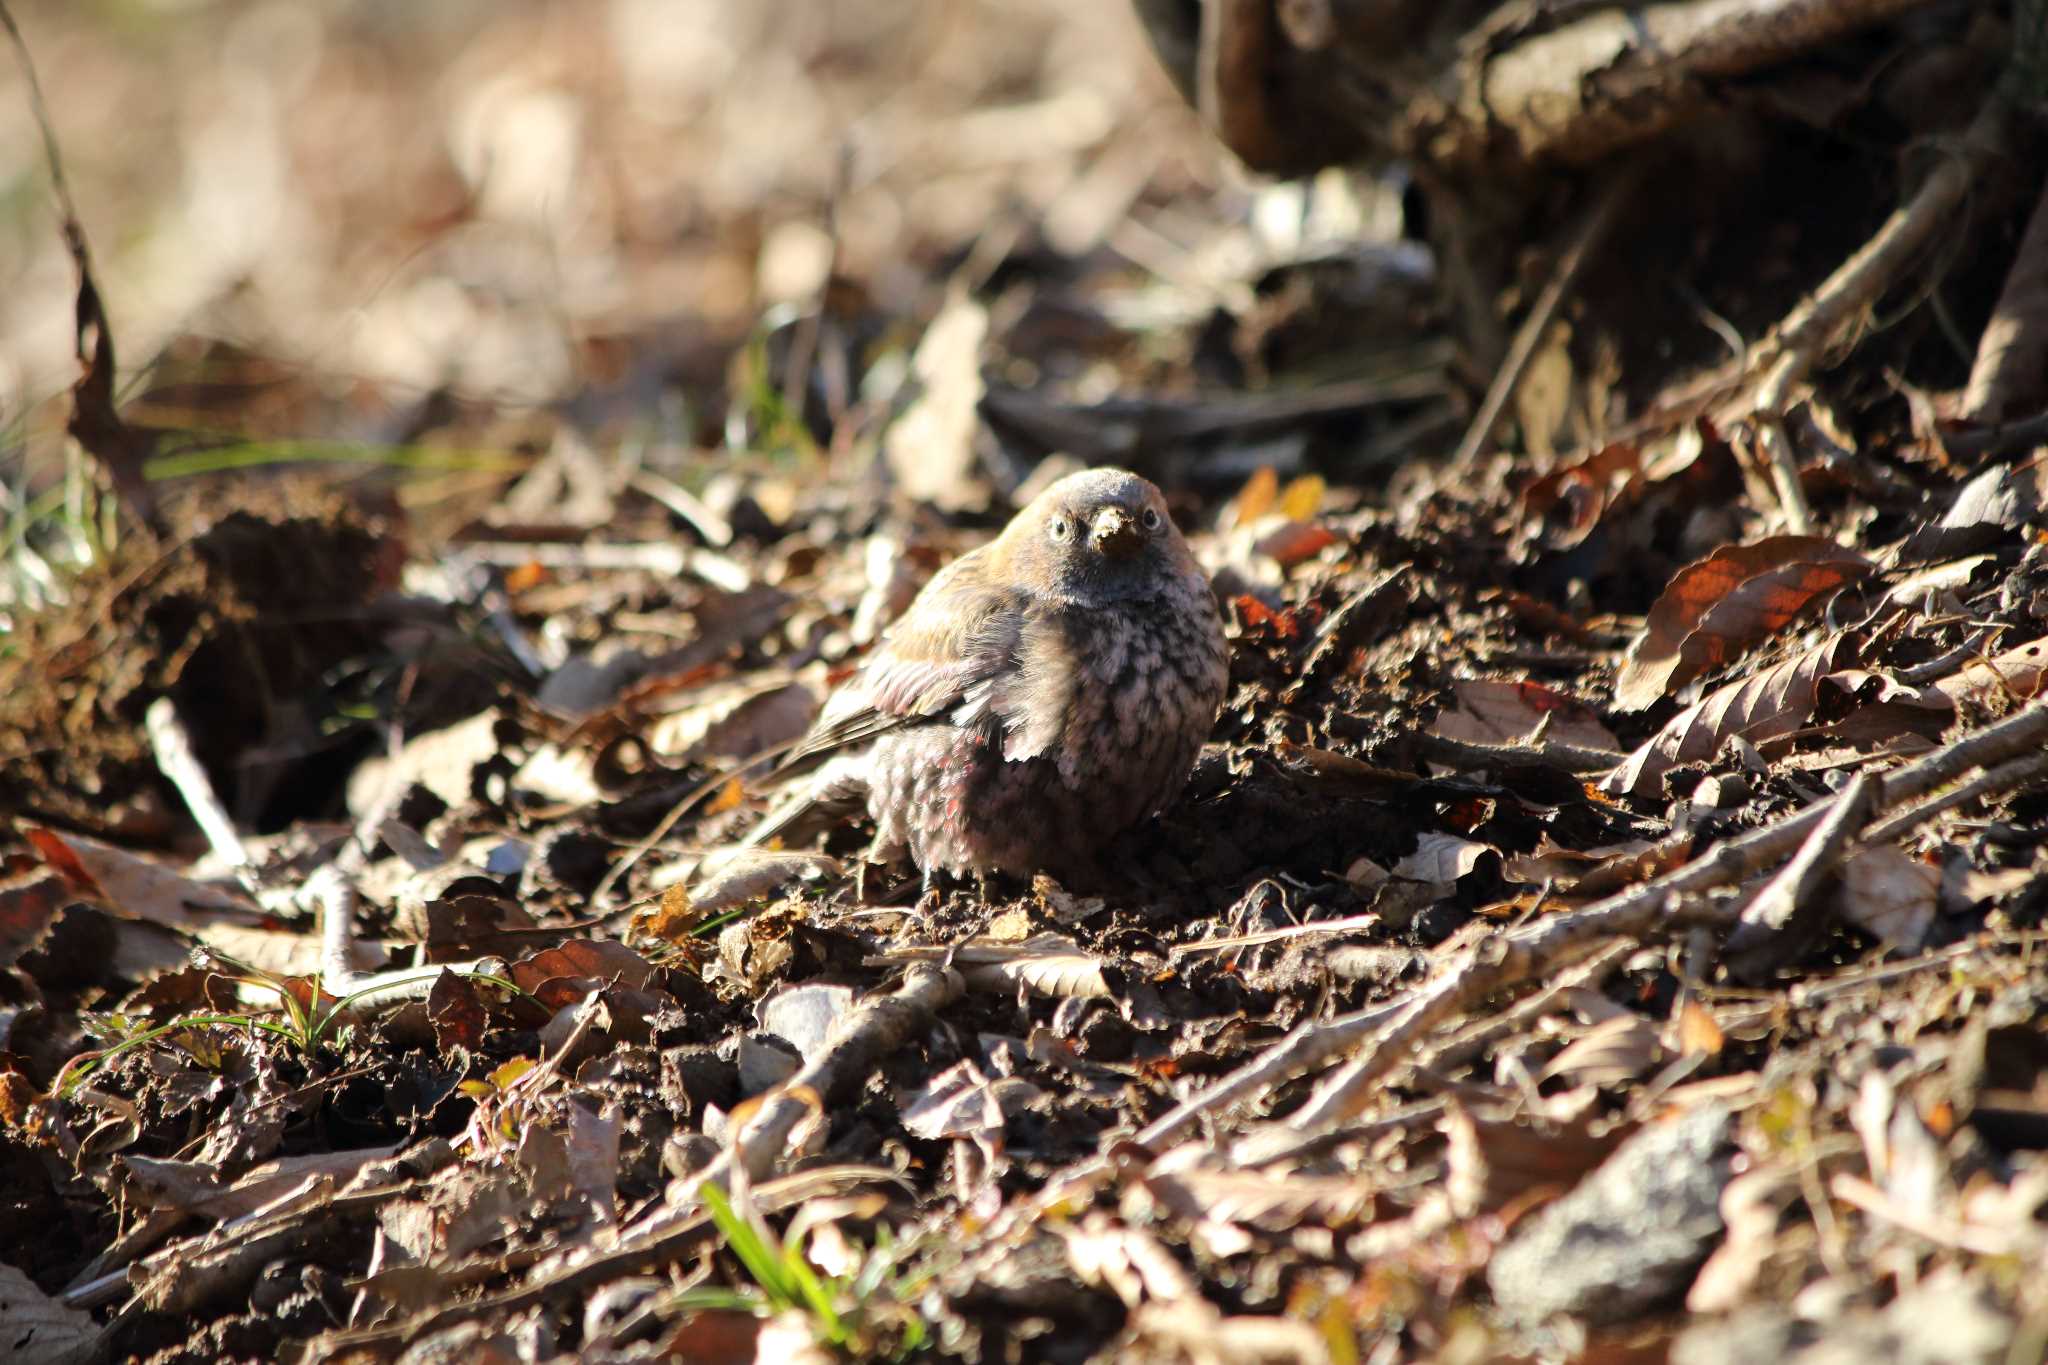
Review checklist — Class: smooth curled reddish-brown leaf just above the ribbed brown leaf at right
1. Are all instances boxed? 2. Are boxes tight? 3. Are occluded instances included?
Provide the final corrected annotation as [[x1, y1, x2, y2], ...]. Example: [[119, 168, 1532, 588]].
[[1614, 536, 1870, 710]]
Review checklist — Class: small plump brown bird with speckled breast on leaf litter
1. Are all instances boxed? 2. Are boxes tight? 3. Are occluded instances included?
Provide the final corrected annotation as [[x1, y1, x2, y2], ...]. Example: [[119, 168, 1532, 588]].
[[745, 469, 1229, 886]]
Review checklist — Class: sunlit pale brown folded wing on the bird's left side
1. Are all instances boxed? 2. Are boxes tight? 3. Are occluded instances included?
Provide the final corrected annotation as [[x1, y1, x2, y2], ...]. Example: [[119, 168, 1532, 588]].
[[782, 551, 1026, 772]]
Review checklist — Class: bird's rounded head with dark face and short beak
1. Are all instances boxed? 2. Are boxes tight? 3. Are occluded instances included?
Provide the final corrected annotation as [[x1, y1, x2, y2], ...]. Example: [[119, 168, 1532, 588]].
[[997, 469, 1194, 606]]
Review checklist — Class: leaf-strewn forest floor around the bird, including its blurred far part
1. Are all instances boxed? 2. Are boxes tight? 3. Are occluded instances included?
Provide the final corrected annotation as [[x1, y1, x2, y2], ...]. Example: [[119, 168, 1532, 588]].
[[0, 0, 2048, 1365]]
